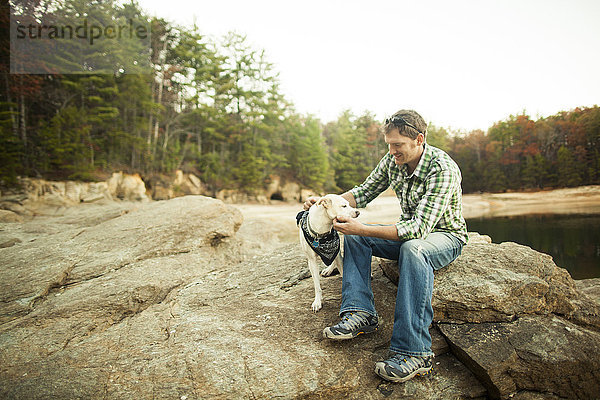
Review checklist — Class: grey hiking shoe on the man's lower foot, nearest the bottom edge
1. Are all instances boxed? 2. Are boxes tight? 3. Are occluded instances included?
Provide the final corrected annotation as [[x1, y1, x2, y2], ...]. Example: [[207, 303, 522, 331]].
[[375, 353, 433, 382]]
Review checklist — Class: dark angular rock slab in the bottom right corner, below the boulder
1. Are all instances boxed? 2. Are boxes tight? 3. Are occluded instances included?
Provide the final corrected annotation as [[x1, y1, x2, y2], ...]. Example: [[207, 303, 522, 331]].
[[439, 315, 600, 399]]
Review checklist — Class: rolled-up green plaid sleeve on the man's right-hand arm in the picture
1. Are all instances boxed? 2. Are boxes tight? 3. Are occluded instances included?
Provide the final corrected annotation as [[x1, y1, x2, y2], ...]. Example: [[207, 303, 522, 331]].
[[396, 170, 461, 240]]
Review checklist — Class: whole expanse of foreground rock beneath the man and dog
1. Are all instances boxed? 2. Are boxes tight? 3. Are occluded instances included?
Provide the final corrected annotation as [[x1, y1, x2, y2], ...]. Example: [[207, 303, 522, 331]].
[[0, 196, 600, 399]]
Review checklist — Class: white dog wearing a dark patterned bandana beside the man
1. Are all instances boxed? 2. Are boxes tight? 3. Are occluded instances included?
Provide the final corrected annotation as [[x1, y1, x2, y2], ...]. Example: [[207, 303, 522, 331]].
[[296, 194, 360, 312]]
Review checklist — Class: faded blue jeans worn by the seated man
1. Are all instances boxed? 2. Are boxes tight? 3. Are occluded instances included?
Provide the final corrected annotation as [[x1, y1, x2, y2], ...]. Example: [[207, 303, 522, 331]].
[[340, 232, 463, 356]]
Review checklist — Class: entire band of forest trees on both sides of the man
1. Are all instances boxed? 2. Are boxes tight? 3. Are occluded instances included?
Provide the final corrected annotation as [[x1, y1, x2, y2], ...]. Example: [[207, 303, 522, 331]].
[[0, 0, 600, 193]]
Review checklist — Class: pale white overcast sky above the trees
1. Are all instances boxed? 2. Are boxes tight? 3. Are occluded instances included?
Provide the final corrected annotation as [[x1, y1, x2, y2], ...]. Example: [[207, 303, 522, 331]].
[[139, 0, 600, 131]]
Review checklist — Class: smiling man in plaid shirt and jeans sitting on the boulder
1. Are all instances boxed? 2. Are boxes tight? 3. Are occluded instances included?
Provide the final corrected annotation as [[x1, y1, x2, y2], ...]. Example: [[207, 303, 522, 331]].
[[305, 110, 468, 382]]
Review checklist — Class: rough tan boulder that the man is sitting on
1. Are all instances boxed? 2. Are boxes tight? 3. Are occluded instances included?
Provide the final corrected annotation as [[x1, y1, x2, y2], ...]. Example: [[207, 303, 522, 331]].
[[379, 236, 600, 328]]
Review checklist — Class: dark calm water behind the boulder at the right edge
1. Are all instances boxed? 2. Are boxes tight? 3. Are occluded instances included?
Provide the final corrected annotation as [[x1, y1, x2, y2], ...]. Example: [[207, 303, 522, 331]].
[[467, 215, 600, 279]]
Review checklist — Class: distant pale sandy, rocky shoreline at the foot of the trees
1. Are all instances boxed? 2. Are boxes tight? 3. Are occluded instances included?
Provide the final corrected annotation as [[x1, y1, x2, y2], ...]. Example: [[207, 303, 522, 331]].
[[0, 170, 600, 223]]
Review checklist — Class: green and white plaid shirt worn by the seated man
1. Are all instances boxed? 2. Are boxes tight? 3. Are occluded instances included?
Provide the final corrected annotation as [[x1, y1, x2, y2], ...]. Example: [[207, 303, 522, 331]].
[[350, 144, 468, 244]]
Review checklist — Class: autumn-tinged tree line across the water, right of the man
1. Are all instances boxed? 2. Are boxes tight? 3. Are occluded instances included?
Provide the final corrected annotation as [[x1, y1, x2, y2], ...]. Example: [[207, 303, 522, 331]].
[[439, 106, 600, 193]]
